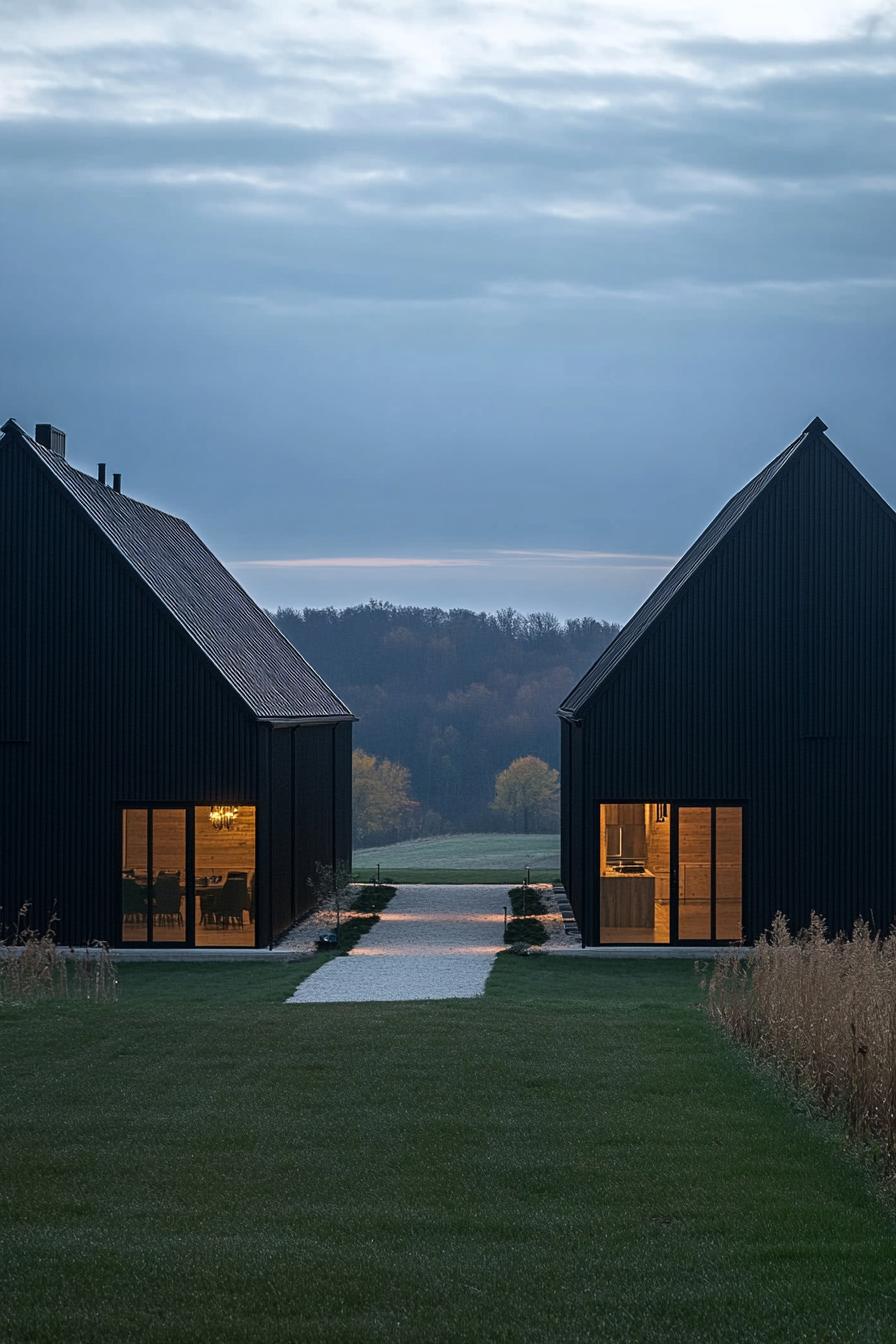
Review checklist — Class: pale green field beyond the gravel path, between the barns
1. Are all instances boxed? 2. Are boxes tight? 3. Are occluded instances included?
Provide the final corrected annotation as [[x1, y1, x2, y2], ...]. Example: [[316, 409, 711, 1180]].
[[353, 833, 560, 884]]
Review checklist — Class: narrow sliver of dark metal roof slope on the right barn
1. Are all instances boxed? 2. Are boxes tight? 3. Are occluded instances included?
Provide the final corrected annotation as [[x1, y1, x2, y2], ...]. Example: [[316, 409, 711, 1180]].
[[557, 419, 827, 719]]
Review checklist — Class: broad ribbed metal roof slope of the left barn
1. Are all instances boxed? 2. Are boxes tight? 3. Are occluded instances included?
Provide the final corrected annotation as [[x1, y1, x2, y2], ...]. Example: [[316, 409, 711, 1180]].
[[3, 419, 355, 722]]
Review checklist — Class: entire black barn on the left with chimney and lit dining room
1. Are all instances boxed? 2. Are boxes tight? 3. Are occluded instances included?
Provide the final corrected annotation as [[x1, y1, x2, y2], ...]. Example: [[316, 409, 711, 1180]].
[[0, 421, 352, 946]]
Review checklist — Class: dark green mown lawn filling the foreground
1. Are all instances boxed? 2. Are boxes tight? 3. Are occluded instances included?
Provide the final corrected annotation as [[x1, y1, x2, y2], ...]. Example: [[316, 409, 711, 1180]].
[[0, 957, 896, 1344]]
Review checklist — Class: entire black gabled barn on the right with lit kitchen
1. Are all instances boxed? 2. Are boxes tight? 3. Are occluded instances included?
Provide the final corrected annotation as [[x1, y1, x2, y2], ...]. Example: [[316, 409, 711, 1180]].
[[559, 419, 896, 946]]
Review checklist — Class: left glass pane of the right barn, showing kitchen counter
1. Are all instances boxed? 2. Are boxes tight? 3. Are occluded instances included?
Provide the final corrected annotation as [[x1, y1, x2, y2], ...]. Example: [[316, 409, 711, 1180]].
[[600, 802, 672, 943]]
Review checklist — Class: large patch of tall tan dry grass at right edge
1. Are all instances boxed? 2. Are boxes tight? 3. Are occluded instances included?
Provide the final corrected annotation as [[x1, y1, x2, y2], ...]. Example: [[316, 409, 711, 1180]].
[[708, 914, 896, 1176]]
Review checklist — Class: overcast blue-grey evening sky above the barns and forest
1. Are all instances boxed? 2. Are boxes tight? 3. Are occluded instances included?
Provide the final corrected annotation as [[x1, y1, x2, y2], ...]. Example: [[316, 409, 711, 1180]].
[[0, 0, 896, 620]]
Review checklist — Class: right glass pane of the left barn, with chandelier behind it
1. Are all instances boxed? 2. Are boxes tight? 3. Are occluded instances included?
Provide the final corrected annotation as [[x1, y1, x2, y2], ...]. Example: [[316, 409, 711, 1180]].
[[193, 802, 255, 948]]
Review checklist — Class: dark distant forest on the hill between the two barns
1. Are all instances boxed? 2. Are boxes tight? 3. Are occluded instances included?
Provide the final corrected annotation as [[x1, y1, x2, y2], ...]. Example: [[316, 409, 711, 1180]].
[[275, 602, 618, 835]]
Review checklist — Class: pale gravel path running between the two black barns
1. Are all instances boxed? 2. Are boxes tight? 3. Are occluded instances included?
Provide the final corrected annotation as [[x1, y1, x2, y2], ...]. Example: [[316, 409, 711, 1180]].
[[286, 886, 506, 1004]]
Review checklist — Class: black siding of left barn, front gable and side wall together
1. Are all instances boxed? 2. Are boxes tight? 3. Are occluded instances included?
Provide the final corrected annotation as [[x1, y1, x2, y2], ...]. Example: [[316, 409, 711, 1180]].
[[0, 439, 352, 945]]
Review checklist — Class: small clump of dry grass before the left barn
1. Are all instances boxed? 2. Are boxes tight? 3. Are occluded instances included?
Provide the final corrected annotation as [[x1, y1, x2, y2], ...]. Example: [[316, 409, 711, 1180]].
[[0, 906, 118, 1007]]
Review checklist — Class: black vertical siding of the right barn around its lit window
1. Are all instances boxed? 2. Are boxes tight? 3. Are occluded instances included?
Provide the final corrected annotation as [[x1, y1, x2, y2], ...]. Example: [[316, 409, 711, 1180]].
[[563, 439, 896, 942]]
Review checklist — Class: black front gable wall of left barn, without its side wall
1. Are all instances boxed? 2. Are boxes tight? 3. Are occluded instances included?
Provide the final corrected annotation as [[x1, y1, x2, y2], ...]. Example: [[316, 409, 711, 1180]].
[[0, 439, 263, 942]]
